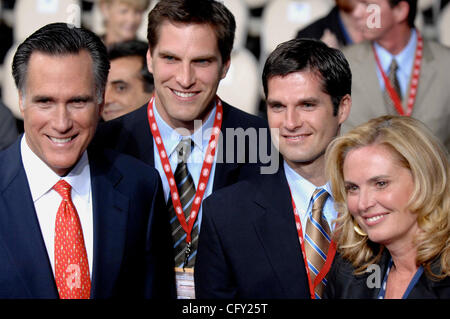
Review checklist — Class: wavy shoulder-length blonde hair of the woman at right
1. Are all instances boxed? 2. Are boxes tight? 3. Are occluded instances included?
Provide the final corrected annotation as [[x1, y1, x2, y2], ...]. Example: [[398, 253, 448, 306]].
[[326, 115, 450, 279]]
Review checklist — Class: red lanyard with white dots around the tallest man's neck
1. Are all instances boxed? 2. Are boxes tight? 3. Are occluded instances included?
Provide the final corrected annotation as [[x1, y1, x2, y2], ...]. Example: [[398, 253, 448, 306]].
[[147, 96, 223, 244]]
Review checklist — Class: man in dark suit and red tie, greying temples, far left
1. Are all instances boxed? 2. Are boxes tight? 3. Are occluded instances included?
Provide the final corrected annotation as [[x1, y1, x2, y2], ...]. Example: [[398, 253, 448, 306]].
[[0, 23, 174, 299]]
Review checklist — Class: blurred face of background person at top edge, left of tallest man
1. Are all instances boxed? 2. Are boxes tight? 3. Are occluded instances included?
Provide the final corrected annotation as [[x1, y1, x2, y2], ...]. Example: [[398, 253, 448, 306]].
[[98, 0, 150, 46]]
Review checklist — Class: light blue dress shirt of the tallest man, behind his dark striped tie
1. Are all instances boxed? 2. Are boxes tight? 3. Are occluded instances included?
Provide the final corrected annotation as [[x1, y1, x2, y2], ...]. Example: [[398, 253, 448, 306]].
[[153, 105, 218, 232]]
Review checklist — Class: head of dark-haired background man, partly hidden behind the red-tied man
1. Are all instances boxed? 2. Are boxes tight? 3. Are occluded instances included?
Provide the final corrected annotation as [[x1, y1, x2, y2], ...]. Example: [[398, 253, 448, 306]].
[[102, 40, 154, 121]]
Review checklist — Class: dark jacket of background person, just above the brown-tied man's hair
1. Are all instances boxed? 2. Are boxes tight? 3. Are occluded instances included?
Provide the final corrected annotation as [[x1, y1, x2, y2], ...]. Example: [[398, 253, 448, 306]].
[[296, 6, 350, 46]]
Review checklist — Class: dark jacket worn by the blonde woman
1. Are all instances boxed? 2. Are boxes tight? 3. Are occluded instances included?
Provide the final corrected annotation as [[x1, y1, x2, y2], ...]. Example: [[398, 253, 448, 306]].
[[324, 249, 450, 299]]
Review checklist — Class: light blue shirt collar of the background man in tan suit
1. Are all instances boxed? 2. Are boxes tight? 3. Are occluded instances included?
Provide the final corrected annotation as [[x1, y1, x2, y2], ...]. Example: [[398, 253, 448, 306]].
[[374, 29, 417, 74]]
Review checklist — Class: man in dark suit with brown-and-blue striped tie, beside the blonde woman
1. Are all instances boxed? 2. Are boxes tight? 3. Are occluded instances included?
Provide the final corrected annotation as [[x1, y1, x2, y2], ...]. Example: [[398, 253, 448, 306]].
[[195, 39, 351, 298]]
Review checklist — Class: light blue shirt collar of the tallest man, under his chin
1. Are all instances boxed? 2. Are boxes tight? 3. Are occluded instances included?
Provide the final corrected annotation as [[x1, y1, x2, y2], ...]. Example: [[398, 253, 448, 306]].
[[153, 100, 216, 157]]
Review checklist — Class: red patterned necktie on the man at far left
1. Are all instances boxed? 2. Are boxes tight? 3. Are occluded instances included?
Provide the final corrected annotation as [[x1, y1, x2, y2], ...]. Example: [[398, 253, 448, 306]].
[[53, 180, 91, 299]]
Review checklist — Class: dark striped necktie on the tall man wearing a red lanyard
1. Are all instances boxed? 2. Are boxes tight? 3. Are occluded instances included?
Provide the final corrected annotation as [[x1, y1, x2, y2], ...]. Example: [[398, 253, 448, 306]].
[[167, 139, 198, 268]]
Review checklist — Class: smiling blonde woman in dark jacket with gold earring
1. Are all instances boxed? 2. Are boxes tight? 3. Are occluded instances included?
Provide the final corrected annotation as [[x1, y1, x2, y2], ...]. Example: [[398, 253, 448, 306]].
[[325, 116, 450, 299]]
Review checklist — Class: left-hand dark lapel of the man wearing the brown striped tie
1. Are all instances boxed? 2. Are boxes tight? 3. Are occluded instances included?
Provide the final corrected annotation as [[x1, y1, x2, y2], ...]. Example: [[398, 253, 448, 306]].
[[254, 169, 309, 298]]
